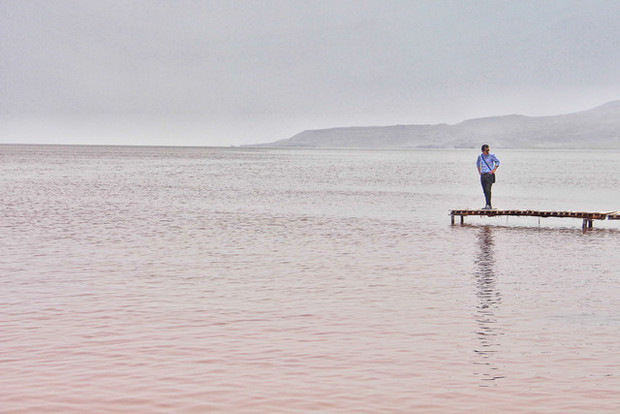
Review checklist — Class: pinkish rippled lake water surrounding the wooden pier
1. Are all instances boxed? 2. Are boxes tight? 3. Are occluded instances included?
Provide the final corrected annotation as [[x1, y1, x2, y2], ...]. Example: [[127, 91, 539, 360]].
[[0, 145, 620, 413]]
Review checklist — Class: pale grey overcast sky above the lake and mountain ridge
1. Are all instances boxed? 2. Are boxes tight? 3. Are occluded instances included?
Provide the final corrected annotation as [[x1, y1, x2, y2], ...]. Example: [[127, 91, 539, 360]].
[[0, 0, 620, 146]]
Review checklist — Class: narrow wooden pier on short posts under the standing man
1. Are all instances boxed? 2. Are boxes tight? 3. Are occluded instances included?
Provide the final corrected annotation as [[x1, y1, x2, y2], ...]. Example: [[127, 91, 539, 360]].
[[450, 209, 620, 230]]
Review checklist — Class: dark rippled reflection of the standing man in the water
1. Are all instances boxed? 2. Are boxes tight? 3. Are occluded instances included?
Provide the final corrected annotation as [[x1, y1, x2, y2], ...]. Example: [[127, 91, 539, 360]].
[[474, 226, 503, 386]]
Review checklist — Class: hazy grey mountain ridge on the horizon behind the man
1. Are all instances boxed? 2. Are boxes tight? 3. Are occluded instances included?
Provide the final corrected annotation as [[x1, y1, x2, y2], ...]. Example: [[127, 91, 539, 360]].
[[252, 100, 620, 149]]
